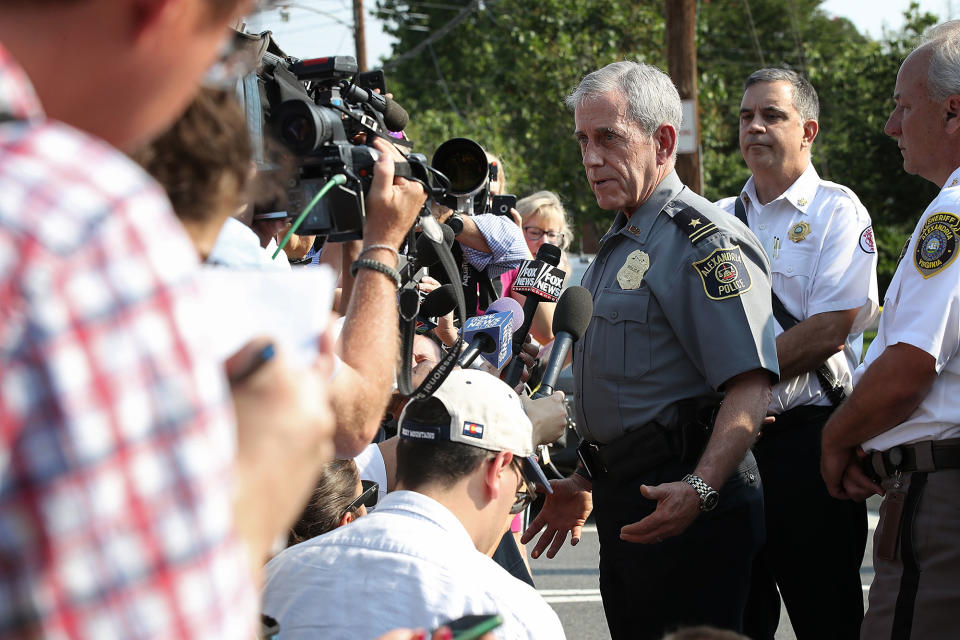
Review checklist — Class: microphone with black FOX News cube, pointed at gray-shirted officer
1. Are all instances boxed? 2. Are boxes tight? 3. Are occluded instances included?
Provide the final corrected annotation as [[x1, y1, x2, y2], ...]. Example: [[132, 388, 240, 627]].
[[503, 244, 566, 387]]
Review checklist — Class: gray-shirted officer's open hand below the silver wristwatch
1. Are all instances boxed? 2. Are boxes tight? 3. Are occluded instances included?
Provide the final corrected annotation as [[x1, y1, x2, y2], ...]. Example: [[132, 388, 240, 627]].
[[620, 482, 700, 544]]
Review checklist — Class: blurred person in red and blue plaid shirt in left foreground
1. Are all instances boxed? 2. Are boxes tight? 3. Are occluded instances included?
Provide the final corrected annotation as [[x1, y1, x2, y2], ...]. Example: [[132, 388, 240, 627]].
[[0, 0, 378, 638]]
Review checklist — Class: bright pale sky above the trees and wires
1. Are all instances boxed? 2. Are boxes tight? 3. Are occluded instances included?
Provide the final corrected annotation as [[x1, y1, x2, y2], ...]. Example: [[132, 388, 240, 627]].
[[248, 0, 960, 68]]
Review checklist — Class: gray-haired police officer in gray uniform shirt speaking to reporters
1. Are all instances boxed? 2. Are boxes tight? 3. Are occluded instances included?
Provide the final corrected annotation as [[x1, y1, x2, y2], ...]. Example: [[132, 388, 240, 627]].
[[524, 62, 779, 639]]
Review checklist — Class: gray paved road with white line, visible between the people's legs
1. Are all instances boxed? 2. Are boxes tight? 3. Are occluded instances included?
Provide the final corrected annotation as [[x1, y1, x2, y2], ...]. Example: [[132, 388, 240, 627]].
[[527, 496, 880, 640]]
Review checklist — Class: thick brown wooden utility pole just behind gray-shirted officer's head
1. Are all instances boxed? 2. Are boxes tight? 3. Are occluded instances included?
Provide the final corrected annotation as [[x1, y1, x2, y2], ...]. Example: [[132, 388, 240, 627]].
[[665, 0, 703, 193]]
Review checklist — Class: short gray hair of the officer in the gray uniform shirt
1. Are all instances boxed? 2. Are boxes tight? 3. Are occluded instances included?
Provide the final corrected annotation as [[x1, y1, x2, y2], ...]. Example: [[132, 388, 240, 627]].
[[564, 60, 683, 141]]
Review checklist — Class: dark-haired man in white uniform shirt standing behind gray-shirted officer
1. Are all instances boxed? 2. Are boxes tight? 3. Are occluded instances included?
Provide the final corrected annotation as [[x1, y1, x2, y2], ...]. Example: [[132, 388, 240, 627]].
[[717, 69, 878, 640]]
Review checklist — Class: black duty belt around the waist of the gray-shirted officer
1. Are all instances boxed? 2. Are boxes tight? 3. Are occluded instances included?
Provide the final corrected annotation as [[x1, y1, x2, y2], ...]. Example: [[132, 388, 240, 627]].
[[577, 400, 720, 480]]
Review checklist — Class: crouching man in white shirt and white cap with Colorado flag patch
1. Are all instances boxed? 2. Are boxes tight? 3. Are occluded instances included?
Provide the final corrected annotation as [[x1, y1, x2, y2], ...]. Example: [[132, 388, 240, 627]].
[[263, 370, 564, 640]]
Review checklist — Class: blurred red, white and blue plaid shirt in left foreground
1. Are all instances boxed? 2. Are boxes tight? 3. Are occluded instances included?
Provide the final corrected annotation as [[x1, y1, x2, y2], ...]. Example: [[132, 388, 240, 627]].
[[0, 46, 256, 639]]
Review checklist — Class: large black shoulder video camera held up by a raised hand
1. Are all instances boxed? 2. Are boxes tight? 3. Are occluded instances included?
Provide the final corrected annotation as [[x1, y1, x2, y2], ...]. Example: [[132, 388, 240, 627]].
[[240, 37, 446, 242]]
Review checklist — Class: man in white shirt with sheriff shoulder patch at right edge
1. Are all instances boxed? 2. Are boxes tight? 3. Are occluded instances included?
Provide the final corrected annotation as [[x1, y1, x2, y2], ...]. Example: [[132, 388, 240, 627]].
[[822, 21, 960, 640]]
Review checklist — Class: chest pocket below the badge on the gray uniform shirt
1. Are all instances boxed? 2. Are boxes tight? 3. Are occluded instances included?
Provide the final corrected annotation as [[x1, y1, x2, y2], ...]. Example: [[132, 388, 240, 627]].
[[588, 288, 650, 381]]
